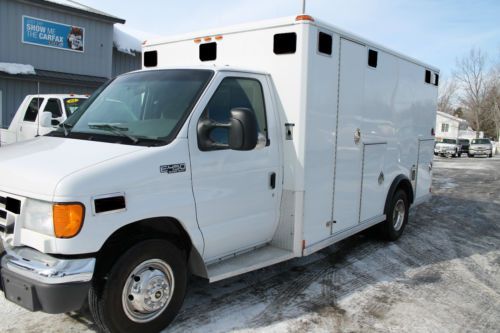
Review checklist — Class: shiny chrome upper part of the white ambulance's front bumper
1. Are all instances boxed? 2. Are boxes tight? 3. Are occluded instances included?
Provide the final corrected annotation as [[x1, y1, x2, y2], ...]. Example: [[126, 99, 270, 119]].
[[1, 247, 95, 284]]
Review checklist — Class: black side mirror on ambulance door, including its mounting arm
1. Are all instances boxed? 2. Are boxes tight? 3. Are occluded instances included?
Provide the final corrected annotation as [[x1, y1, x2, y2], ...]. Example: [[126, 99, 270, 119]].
[[198, 108, 258, 151]]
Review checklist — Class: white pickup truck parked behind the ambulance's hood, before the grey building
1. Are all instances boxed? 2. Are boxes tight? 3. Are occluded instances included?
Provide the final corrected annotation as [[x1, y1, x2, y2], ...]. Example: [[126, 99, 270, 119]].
[[0, 94, 88, 146]]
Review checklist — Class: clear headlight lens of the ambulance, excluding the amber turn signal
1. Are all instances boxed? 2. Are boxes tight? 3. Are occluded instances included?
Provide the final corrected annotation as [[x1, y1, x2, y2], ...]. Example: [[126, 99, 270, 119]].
[[23, 199, 54, 236]]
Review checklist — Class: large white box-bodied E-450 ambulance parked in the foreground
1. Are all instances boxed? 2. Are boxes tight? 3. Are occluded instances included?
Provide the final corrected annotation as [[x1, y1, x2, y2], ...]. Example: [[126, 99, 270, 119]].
[[0, 15, 438, 332]]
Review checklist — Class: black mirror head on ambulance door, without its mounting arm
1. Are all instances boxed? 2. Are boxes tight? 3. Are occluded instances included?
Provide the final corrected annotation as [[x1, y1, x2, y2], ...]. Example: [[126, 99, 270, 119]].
[[229, 108, 259, 151]]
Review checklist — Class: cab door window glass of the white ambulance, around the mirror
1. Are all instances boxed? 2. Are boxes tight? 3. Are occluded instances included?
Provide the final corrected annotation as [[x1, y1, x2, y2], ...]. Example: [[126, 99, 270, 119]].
[[201, 77, 268, 148]]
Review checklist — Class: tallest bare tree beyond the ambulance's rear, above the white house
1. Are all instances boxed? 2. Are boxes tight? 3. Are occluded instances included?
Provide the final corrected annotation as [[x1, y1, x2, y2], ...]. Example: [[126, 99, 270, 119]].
[[454, 48, 486, 131]]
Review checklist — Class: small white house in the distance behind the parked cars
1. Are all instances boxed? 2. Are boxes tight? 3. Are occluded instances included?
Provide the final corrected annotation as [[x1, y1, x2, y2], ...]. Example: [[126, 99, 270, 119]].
[[436, 111, 483, 141]]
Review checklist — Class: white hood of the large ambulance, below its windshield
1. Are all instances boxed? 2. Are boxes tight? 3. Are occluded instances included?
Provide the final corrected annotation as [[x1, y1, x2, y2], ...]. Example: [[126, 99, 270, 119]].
[[0, 136, 146, 200]]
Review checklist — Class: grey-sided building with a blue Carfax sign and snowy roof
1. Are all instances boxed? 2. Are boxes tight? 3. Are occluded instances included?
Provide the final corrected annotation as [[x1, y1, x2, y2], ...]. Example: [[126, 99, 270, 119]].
[[0, 0, 141, 128]]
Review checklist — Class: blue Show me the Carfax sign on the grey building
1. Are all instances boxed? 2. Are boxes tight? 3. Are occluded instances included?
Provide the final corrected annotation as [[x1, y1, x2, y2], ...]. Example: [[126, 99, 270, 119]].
[[23, 16, 85, 52]]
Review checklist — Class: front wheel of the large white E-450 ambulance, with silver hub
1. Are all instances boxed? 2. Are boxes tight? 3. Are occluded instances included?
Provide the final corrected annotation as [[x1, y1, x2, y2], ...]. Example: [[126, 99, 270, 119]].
[[89, 240, 187, 333]]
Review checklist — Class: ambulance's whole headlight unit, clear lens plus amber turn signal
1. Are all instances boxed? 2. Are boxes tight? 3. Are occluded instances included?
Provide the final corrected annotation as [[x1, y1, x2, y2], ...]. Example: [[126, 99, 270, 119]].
[[23, 199, 85, 238]]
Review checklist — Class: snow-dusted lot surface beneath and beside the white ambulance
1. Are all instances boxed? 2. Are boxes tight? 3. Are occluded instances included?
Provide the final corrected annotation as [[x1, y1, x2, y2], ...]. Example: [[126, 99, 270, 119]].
[[0, 158, 500, 333]]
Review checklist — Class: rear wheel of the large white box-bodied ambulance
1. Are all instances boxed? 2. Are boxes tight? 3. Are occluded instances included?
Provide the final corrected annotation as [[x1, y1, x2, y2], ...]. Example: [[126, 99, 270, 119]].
[[379, 189, 410, 241]]
